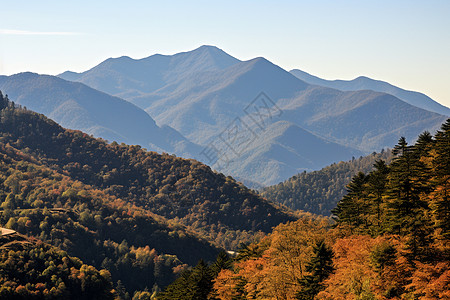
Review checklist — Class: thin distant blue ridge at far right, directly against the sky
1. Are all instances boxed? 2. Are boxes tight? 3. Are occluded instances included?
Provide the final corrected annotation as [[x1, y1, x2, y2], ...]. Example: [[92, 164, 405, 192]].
[[290, 69, 450, 116]]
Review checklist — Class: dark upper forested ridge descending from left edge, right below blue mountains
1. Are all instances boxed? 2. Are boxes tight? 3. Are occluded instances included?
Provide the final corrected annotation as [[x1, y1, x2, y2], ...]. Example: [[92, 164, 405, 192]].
[[0, 91, 295, 249]]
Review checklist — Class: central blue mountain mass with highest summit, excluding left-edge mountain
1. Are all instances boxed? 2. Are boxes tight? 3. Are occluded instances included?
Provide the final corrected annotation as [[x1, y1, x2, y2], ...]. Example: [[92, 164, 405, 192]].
[[60, 46, 445, 186]]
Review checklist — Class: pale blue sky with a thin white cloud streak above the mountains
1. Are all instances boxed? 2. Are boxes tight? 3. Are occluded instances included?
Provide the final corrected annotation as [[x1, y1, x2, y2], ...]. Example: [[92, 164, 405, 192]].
[[0, 0, 450, 106]]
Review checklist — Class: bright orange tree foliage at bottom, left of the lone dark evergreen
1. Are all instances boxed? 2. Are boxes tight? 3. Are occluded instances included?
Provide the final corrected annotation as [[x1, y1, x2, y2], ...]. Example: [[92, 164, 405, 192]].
[[214, 218, 333, 300]]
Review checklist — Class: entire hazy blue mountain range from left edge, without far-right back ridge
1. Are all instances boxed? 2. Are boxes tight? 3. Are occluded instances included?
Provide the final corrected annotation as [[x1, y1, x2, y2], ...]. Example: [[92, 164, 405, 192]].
[[0, 46, 446, 186]]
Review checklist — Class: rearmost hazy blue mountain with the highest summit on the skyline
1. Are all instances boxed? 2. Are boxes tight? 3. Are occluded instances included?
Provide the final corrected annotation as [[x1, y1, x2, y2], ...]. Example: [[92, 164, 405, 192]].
[[58, 46, 239, 99]]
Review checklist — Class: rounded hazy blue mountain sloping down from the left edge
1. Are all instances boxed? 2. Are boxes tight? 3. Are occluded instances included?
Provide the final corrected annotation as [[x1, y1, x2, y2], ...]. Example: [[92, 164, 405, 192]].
[[0, 73, 198, 155]]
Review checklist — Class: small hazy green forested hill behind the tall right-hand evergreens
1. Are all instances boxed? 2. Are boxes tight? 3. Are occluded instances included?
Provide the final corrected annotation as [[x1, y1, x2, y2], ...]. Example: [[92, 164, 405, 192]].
[[261, 150, 392, 216]]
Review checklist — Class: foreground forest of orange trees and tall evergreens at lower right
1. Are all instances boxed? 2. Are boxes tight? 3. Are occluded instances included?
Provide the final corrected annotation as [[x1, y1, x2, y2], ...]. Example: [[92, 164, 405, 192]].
[[158, 119, 450, 300]]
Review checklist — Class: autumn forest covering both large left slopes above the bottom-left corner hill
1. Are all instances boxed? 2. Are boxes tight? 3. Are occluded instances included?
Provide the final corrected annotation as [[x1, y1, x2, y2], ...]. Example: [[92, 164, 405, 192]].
[[0, 93, 297, 299]]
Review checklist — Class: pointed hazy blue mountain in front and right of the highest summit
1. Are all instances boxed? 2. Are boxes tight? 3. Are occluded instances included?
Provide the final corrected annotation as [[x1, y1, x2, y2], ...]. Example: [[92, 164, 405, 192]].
[[137, 58, 307, 144]]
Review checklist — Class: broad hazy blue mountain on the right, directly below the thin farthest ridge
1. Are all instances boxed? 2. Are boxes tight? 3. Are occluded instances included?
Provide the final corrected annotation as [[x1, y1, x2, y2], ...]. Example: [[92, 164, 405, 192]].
[[278, 86, 447, 153]]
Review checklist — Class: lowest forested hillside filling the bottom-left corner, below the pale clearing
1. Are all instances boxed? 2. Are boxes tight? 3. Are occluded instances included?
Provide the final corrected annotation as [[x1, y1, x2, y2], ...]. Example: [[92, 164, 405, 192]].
[[0, 233, 115, 300]]
